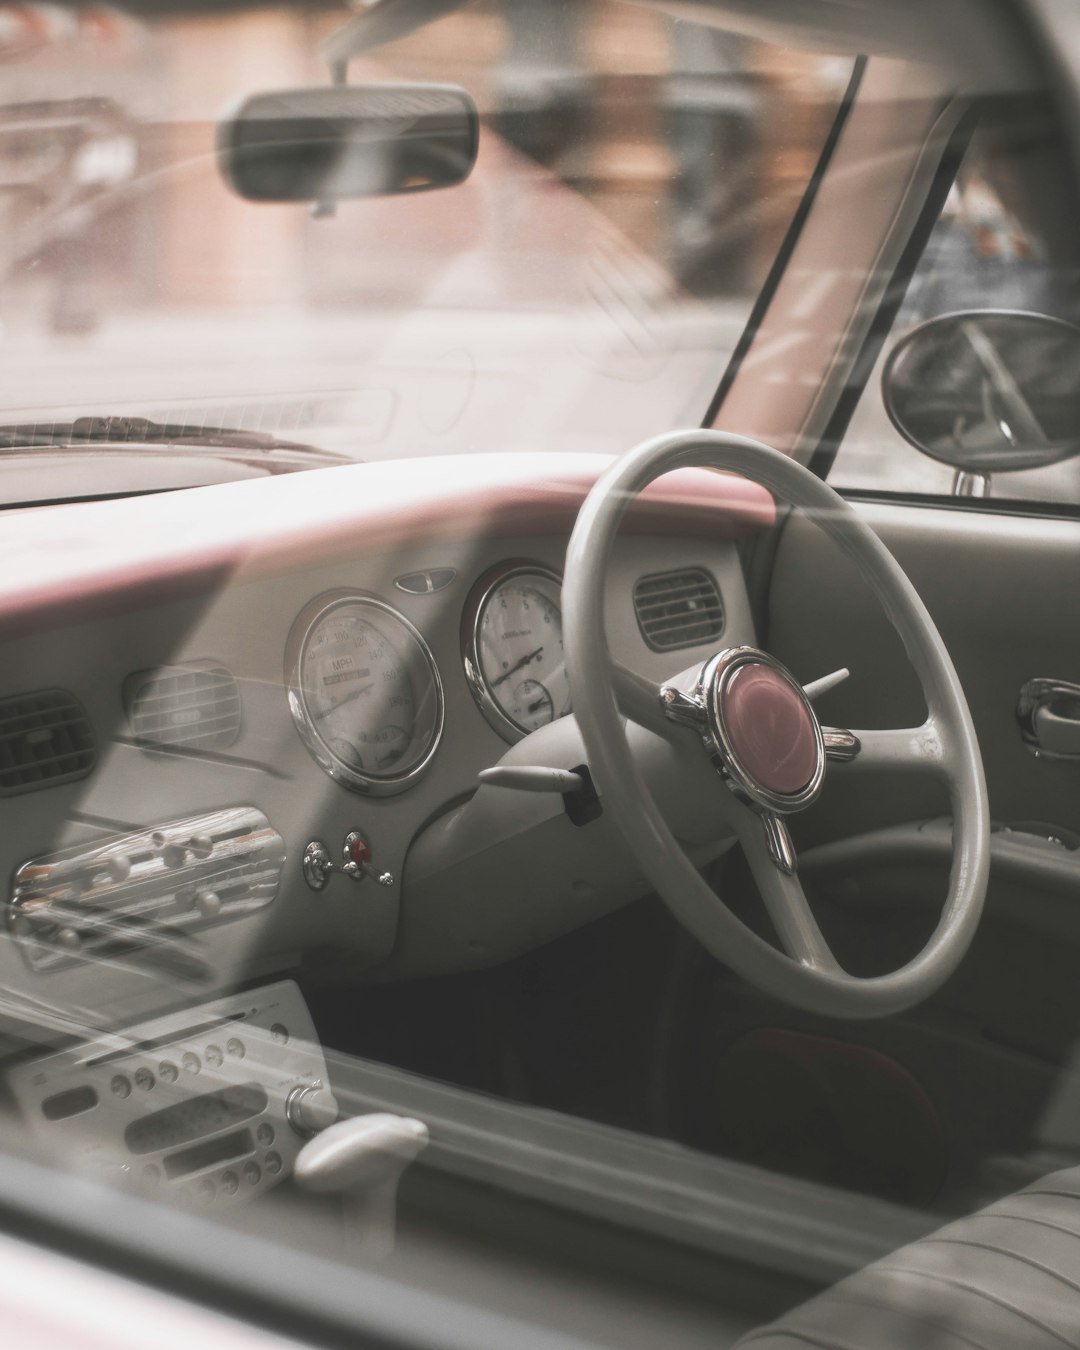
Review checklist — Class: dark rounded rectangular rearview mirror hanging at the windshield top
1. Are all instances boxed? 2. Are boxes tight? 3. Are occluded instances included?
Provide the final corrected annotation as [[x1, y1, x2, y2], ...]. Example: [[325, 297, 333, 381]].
[[217, 84, 479, 204]]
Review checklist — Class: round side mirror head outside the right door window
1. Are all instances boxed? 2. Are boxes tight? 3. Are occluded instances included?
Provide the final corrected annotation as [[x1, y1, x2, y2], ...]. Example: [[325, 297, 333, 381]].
[[882, 309, 1080, 475]]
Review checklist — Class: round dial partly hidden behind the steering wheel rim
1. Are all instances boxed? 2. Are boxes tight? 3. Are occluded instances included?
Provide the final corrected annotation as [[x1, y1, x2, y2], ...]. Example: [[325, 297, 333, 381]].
[[463, 563, 570, 741]]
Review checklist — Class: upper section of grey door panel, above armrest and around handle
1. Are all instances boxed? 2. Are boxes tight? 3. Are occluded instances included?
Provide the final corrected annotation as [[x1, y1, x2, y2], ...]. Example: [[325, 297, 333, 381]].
[[767, 504, 1080, 847]]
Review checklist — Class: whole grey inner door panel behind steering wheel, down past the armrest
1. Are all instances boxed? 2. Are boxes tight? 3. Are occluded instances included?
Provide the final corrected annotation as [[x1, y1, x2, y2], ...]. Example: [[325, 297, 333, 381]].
[[761, 504, 1080, 1210]]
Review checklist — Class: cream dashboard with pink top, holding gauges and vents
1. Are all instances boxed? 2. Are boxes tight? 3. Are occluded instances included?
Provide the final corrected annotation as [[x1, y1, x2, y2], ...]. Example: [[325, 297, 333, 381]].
[[0, 455, 772, 1041]]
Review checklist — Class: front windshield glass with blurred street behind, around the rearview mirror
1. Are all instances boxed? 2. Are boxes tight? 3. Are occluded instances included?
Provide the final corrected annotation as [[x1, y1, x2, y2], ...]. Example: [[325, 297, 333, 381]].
[[0, 0, 851, 459]]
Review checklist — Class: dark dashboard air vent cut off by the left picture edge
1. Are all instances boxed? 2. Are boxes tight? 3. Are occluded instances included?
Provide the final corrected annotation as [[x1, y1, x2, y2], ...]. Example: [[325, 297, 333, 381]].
[[0, 689, 97, 797]]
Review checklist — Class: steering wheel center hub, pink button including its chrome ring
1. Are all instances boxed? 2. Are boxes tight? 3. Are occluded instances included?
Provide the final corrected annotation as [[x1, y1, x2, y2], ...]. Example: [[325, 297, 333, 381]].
[[699, 647, 825, 814]]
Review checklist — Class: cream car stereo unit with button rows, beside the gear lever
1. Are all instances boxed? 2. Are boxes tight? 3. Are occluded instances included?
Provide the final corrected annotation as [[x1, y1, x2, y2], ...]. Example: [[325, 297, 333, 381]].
[[8, 980, 338, 1203]]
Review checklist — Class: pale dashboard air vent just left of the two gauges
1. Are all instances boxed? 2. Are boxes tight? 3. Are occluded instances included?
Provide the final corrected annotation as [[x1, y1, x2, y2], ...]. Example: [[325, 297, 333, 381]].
[[124, 666, 240, 751]]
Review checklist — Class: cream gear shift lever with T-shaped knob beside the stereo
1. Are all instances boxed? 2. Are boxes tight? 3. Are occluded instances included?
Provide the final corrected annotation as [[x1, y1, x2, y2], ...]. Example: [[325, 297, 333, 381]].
[[293, 1111, 429, 1260]]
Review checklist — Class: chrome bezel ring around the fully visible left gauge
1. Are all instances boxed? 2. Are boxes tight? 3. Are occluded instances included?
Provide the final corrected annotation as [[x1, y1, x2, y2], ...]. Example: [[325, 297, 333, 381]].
[[285, 590, 446, 797]]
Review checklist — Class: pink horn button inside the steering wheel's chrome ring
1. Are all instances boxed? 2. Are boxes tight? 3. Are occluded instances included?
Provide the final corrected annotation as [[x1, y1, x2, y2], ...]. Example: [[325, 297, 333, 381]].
[[721, 664, 818, 797]]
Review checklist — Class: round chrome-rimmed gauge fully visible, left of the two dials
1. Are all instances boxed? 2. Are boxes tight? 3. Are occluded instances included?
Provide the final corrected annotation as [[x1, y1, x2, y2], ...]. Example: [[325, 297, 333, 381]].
[[286, 591, 443, 794]]
